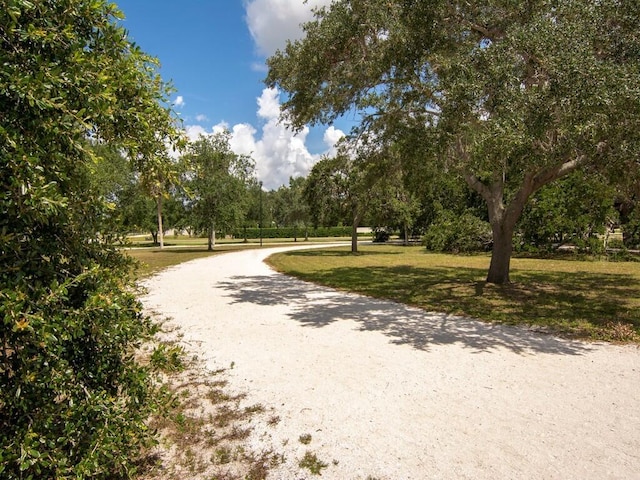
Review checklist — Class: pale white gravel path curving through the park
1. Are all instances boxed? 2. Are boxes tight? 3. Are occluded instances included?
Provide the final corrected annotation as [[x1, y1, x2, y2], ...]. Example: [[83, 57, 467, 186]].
[[143, 247, 640, 480]]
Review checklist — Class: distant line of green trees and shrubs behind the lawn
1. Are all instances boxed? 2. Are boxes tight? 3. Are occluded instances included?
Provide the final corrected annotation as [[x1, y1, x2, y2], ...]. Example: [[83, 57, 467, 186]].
[[91, 133, 640, 253]]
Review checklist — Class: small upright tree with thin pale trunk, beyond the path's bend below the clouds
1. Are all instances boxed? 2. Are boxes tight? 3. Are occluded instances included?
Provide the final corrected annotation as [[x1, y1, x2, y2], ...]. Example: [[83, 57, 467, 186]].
[[182, 132, 254, 250]]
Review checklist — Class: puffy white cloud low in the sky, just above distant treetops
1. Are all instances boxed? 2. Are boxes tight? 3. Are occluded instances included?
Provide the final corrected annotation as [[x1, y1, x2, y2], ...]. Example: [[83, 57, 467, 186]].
[[186, 88, 344, 190]]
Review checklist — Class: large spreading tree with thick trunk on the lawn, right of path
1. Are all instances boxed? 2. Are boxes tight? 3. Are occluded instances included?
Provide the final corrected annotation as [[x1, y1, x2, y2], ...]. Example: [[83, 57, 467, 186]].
[[266, 0, 640, 283]]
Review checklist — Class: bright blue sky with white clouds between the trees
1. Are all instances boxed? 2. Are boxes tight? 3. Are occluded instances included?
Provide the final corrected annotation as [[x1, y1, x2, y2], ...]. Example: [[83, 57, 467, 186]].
[[116, 0, 342, 189]]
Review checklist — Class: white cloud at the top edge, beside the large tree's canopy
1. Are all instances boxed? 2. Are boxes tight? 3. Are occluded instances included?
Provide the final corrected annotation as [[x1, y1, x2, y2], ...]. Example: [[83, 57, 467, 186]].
[[245, 0, 331, 56]]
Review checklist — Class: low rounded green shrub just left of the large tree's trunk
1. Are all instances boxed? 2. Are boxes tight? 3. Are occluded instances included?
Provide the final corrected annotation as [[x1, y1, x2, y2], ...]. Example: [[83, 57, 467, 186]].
[[423, 211, 491, 253]]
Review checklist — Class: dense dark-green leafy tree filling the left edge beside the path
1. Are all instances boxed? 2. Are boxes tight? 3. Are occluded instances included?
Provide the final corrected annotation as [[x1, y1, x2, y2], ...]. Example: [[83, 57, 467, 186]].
[[0, 0, 176, 479]]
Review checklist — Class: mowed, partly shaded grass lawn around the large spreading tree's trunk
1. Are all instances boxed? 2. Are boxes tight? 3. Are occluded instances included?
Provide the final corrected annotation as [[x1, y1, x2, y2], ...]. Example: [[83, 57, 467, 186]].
[[268, 245, 640, 343]]
